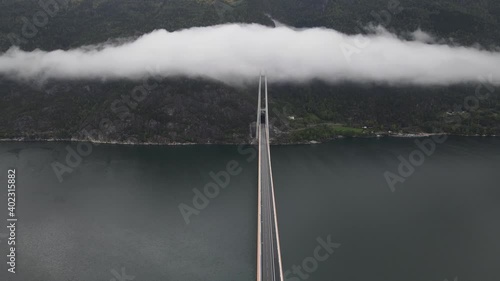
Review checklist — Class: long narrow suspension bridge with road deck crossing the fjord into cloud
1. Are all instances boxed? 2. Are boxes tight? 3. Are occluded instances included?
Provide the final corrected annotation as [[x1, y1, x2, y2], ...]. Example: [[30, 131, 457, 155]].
[[255, 75, 284, 281]]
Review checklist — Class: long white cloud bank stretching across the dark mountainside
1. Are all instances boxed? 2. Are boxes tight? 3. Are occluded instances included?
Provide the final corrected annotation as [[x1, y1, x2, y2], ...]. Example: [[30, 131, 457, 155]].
[[0, 24, 500, 85]]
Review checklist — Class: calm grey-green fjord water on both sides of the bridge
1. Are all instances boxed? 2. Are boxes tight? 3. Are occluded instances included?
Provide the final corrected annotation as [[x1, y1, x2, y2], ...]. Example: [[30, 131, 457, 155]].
[[0, 137, 500, 281]]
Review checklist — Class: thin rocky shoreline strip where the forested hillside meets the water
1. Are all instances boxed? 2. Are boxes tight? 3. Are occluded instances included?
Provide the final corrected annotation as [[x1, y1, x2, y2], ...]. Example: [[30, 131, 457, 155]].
[[0, 133, 499, 146]]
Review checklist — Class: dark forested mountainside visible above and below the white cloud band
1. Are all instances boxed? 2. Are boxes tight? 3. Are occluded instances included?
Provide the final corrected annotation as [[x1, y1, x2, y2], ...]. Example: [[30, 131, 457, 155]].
[[0, 0, 500, 143]]
